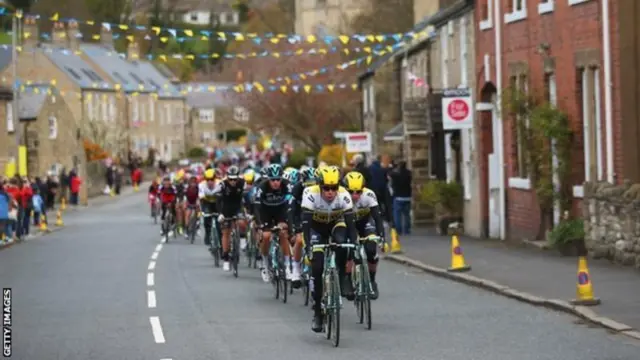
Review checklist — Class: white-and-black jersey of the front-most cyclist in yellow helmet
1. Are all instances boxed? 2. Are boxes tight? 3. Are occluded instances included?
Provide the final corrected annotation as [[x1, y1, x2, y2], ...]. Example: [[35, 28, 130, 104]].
[[300, 185, 353, 224]]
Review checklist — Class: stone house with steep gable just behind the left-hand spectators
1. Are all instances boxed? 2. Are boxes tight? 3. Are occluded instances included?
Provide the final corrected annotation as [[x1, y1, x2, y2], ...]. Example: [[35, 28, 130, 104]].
[[18, 84, 87, 204]]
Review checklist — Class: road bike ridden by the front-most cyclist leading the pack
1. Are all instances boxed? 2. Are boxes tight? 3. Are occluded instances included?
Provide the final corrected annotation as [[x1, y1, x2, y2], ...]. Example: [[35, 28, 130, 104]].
[[312, 239, 355, 347]]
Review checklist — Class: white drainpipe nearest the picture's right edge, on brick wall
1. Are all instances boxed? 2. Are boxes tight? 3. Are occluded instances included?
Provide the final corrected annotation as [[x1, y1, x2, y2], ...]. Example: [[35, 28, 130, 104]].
[[602, 0, 615, 183]]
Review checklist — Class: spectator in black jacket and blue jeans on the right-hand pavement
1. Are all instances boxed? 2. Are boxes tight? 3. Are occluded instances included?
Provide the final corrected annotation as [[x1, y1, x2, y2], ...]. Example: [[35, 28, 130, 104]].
[[390, 161, 412, 235]]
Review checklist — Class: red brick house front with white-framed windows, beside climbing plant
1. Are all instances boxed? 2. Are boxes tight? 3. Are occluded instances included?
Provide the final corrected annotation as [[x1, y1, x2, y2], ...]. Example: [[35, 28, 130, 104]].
[[476, 0, 612, 239]]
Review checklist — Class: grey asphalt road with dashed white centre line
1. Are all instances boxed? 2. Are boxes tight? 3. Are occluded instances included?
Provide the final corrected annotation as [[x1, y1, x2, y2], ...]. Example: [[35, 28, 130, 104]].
[[0, 194, 640, 360]]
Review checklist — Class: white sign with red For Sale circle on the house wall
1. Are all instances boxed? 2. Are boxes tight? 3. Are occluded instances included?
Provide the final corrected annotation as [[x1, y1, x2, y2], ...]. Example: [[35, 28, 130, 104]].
[[442, 88, 473, 130]]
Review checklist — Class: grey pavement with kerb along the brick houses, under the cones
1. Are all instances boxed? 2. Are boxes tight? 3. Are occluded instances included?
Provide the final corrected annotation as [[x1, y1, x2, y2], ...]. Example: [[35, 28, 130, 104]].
[[387, 229, 640, 338]]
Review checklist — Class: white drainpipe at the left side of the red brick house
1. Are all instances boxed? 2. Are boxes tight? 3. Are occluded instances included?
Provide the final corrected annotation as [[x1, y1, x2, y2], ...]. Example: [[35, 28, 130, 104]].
[[493, 0, 507, 240]]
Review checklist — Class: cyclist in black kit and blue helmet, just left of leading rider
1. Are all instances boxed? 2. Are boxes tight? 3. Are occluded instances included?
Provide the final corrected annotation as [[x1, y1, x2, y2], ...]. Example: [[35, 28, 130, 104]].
[[255, 164, 292, 282]]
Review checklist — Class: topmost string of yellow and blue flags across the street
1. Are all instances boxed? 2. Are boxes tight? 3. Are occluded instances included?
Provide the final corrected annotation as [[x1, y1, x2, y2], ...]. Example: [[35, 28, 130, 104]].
[[0, 7, 430, 45]]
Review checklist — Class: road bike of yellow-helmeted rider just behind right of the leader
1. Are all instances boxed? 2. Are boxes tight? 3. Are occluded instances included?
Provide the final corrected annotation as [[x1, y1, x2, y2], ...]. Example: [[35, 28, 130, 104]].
[[351, 235, 381, 330]]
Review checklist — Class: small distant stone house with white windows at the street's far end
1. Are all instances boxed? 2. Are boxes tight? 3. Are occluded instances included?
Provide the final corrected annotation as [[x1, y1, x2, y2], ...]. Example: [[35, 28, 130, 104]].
[[183, 83, 249, 149]]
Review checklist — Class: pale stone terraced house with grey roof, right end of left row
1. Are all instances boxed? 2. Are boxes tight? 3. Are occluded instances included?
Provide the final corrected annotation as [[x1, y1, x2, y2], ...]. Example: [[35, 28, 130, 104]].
[[80, 28, 186, 160]]
